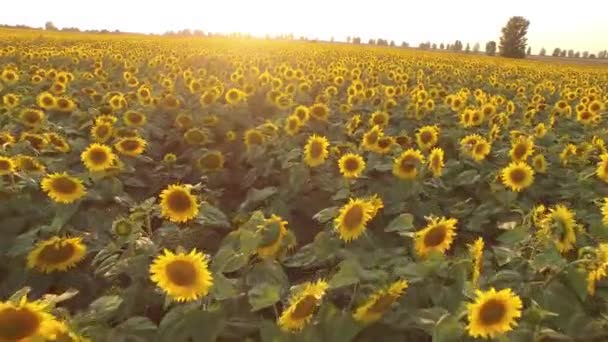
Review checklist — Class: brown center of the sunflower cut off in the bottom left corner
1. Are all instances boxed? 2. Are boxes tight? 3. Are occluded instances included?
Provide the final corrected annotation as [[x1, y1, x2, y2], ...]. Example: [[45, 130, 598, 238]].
[[0, 308, 40, 341]]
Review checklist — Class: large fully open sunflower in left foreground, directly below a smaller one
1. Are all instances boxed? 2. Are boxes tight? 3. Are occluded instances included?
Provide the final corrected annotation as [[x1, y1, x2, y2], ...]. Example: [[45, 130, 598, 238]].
[[150, 249, 213, 302]]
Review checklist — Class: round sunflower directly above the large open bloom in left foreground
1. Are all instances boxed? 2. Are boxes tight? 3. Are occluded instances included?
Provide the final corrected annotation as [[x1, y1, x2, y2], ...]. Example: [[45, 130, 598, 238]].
[[159, 184, 199, 223]]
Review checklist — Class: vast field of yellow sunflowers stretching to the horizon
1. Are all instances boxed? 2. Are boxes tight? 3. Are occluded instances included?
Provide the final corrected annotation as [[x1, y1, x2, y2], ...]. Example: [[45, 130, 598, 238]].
[[0, 29, 608, 342]]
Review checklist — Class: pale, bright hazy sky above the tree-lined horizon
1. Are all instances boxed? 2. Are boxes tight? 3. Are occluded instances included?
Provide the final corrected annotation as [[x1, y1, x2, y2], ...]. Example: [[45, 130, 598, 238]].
[[0, 0, 608, 52]]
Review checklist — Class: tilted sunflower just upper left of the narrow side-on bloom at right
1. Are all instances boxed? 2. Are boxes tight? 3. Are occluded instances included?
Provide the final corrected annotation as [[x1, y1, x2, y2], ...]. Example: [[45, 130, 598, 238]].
[[414, 217, 458, 258]]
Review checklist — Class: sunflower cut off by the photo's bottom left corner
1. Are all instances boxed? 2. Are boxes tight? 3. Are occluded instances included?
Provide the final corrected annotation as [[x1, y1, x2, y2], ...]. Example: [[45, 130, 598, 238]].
[[0, 297, 59, 342]]
